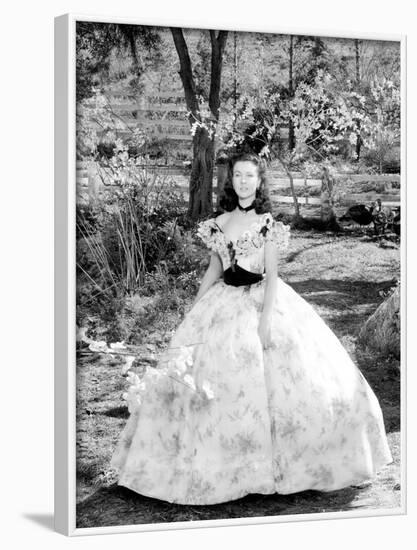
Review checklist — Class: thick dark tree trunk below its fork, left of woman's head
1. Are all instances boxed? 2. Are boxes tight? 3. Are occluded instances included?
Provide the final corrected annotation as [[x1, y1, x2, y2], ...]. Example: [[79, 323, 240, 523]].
[[188, 128, 214, 220]]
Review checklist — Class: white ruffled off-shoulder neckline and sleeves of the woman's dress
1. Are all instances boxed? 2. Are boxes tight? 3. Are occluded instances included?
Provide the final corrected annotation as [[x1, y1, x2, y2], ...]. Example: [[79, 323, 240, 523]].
[[197, 212, 290, 272]]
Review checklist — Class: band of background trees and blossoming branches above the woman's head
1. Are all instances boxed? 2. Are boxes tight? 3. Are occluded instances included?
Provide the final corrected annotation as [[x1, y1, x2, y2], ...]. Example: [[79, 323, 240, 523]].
[[77, 23, 400, 220]]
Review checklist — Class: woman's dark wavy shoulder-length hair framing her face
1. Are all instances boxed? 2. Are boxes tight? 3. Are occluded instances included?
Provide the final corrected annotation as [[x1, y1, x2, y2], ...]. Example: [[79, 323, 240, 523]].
[[219, 153, 271, 218]]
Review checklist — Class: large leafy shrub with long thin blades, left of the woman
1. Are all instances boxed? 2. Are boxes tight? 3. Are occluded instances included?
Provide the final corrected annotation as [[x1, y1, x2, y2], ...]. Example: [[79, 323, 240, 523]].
[[77, 155, 206, 343]]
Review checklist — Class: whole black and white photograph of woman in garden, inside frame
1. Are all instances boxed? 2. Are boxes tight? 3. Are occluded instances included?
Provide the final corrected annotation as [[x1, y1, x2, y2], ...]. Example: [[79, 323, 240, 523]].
[[58, 17, 405, 540]]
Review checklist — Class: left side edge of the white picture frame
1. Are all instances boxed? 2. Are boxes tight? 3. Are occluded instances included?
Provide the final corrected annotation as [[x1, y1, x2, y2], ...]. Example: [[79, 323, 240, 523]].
[[54, 14, 73, 536]]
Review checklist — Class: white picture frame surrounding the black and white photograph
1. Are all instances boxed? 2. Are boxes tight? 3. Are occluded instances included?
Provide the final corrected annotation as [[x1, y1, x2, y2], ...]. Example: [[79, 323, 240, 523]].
[[55, 14, 407, 536]]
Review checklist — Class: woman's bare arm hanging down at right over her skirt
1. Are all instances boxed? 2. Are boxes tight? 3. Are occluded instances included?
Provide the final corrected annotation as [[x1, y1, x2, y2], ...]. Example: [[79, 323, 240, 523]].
[[258, 241, 278, 349]]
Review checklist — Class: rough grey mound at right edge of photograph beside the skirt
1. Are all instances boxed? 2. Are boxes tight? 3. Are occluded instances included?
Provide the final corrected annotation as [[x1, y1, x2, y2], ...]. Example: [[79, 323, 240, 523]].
[[359, 287, 401, 358]]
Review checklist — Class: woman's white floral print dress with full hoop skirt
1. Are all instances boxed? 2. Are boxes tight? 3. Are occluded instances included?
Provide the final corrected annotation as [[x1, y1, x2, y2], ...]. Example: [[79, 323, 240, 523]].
[[112, 213, 392, 504]]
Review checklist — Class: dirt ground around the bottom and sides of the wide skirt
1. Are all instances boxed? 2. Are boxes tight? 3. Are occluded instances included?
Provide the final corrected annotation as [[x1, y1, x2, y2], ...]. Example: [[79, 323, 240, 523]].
[[77, 224, 401, 528]]
